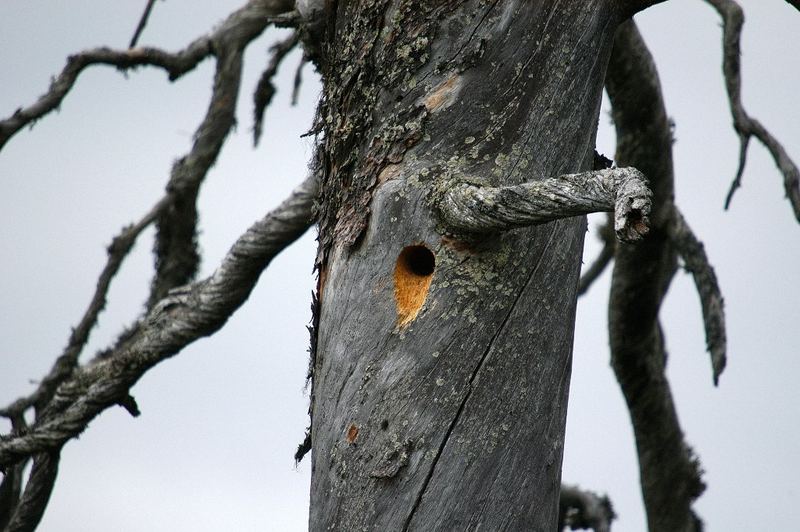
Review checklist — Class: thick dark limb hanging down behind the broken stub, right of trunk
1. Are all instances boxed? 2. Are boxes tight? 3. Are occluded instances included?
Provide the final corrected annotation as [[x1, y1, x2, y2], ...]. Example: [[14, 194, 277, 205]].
[[606, 21, 704, 532]]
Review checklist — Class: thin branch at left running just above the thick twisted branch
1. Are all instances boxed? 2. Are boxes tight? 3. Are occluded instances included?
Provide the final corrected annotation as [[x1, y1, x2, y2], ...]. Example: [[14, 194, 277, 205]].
[[0, 196, 172, 417]]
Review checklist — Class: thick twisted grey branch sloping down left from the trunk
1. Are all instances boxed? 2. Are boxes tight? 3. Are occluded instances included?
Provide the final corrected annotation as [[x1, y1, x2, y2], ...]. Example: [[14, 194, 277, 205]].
[[0, 177, 318, 467]]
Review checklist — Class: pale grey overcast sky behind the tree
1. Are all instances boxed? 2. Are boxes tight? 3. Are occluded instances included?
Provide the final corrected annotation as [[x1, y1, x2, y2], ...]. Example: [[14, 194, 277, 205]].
[[0, 0, 800, 532]]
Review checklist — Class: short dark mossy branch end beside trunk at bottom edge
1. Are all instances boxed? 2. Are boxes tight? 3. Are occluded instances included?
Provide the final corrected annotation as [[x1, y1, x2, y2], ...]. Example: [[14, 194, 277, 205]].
[[558, 484, 616, 532]]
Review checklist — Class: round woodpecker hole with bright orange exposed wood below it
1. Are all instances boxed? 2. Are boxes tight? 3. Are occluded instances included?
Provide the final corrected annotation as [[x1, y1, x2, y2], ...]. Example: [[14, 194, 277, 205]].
[[394, 245, 436, 326]]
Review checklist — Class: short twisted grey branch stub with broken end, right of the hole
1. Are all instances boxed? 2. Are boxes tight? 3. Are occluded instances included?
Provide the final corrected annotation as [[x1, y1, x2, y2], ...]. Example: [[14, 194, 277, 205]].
[[438, 168, 651, 241]]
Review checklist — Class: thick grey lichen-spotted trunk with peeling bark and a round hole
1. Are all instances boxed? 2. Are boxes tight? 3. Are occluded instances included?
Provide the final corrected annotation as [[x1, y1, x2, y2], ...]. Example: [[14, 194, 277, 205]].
[[310, 0, 621, 532]]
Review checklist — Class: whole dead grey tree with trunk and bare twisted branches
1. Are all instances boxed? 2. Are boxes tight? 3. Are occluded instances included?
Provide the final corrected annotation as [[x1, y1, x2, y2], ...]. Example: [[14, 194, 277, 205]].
[[0, 0, 800, 531]]
